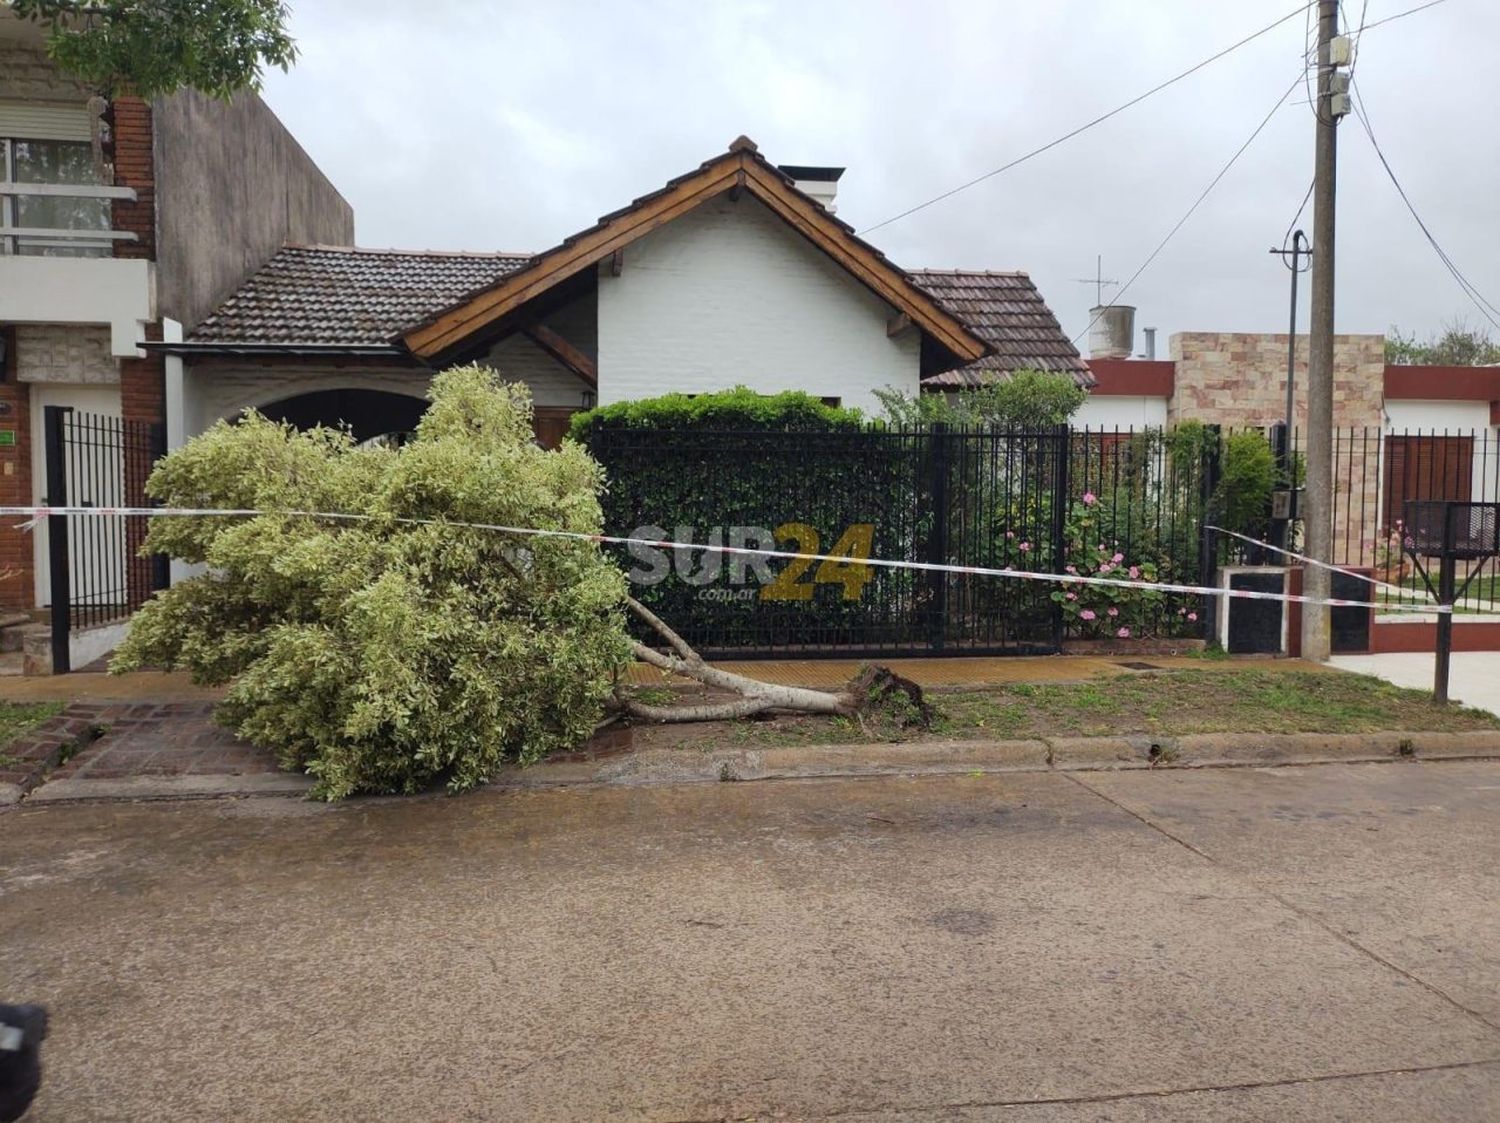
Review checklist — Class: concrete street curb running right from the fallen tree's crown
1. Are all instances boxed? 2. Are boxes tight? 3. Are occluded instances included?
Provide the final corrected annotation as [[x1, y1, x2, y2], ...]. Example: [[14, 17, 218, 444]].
[[489, 730, 1500, 789]]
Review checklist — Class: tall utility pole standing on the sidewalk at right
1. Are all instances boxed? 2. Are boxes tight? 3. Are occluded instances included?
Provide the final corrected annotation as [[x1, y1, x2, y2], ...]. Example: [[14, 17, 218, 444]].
[[1302, 0, 1350, 663]]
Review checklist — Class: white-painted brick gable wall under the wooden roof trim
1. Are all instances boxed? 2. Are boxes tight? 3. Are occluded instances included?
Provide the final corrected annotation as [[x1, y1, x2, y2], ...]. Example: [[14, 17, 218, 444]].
[[599, 195, 921, 414]]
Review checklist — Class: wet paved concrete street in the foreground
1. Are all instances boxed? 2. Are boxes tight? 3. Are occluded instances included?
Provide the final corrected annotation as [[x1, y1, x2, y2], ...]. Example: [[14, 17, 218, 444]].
[[0, 762, 1500, 1123]]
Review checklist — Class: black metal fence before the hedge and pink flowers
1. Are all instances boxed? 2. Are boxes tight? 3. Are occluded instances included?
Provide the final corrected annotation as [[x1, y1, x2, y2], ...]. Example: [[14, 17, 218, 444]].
[[590, 426, 1218, 657]]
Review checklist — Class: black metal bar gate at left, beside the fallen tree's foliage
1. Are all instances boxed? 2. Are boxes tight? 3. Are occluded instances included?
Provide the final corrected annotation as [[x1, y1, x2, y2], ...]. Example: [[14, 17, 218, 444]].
[[44, 406, 168, 675]]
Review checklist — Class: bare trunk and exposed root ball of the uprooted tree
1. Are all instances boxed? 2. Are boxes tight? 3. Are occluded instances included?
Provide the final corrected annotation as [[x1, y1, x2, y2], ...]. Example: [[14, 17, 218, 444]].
[[615, 597, 933, 729]]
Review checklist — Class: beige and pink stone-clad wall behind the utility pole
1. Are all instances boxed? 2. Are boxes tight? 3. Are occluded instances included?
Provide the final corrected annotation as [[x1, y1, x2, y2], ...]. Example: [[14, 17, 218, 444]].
[[1167, 331, 1386, 429]]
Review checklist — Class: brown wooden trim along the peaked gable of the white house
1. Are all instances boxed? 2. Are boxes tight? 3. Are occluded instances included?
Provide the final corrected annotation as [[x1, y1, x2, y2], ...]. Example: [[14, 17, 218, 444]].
[[404, 147, 989, 363]]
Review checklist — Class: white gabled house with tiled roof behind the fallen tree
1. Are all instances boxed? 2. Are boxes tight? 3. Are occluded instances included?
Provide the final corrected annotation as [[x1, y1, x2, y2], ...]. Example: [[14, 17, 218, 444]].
[[158, 136, 1091, 445]]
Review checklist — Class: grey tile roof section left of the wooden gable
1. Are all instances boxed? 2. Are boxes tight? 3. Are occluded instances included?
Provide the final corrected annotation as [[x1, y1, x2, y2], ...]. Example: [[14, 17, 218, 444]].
[[186, 246, 531, 346]]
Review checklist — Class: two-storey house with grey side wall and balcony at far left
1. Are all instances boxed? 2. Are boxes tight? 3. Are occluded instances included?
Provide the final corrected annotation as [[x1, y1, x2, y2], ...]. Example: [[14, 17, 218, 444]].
[[0, 6, 354, 610]]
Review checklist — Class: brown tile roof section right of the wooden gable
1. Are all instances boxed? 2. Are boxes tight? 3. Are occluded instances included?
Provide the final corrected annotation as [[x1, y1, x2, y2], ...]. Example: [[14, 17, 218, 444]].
[[911, 268, 1094, 388]]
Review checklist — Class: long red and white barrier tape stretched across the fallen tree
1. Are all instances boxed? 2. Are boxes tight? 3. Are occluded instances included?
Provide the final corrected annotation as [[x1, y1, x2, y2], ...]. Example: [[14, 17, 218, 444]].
[[0, 507, 1452, 613]]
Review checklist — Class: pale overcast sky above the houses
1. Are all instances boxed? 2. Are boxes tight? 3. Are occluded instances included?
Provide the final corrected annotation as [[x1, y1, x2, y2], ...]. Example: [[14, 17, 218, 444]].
[[266, 0, 1500, 354]]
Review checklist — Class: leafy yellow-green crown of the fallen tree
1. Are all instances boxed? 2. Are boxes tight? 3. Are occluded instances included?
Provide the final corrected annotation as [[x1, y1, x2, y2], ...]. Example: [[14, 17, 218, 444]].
[[113, 366, 629, 799]]
